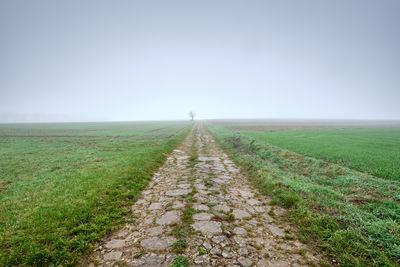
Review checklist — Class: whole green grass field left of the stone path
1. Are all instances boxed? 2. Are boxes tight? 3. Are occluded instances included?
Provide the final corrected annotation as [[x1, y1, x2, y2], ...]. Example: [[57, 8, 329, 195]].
[[0, 122, 191, 266]]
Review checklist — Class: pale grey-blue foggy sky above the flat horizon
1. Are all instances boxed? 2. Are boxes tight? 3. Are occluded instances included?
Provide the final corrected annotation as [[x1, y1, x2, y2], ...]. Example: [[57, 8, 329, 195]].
[[0, 0, 400, 121]]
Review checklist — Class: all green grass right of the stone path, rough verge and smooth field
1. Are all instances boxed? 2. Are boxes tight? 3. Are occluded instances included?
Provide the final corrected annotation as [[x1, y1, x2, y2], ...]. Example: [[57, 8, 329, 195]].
[[208, 122, 400, 266]]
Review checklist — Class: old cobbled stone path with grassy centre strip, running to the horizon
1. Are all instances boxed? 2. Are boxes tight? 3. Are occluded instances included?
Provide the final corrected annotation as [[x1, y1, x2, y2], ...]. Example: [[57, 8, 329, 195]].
[[89, 124, 319, 266]]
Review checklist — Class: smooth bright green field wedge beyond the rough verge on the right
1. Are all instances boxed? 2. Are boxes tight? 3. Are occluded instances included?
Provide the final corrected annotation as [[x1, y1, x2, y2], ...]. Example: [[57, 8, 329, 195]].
[[243, 128, 400, 180]]
